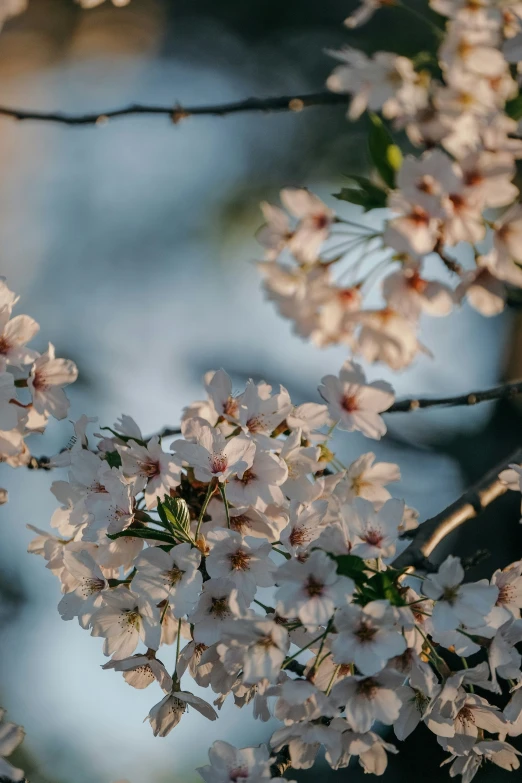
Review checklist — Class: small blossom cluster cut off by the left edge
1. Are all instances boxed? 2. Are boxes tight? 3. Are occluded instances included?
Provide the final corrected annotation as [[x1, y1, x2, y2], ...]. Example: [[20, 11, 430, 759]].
[[0, 278, 78, 503]]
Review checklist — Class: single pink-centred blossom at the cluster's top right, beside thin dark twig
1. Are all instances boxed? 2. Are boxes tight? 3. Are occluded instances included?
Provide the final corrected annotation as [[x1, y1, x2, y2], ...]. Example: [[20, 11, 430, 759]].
[[319, 361, 395, 440]]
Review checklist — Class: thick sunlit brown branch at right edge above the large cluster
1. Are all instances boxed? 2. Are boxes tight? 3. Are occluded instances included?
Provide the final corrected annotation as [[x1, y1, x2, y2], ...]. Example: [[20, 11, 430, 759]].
[[393, 449, 522, 571]]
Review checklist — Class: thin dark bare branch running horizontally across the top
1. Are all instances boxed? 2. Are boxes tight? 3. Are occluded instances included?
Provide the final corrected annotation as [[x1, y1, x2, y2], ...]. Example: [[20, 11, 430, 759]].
[[0, 91, 348, 125]]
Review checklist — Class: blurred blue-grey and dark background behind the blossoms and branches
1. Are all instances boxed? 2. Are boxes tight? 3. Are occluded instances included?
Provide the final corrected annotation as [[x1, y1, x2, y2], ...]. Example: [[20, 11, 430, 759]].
[[0, 0, 522, 783]]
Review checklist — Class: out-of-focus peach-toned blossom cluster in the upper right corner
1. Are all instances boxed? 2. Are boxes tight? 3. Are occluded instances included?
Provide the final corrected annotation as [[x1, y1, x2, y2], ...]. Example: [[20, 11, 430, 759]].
[[258, 0, 522, 370]]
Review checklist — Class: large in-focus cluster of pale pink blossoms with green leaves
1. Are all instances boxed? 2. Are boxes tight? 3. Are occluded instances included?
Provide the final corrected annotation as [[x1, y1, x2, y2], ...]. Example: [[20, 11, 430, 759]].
[[26, 362, 522, 783]]
